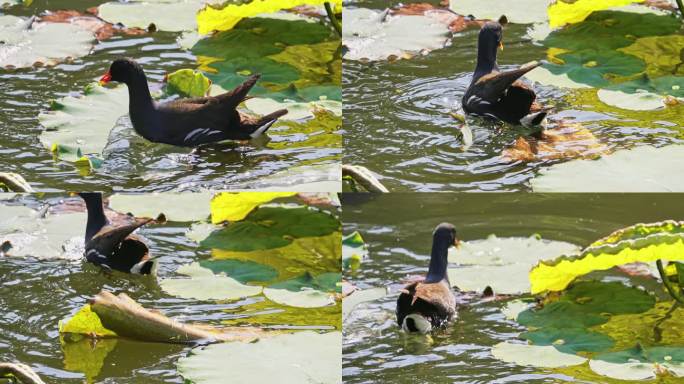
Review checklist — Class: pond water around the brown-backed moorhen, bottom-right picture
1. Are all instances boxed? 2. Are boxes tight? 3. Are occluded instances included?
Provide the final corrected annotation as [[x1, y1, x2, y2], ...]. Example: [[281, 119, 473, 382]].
[[342, 193, 684, 383]]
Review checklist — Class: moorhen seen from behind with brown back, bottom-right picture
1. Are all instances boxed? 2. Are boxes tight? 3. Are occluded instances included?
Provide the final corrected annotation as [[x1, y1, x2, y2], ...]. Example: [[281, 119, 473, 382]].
[[396, 223, 458, 333]]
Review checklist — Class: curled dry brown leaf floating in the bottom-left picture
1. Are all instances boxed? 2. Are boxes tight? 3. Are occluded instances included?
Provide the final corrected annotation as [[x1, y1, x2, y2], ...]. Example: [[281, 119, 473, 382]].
[[90, 290, 269, 344]]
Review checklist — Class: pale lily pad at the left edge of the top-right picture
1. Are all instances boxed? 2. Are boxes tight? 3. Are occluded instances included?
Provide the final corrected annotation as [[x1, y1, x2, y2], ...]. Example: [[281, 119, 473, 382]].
[[342, 7, 449, 61]]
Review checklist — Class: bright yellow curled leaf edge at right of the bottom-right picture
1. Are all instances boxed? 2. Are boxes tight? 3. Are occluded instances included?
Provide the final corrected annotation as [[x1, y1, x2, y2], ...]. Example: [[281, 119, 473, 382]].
[[530, 220, 684, 293]]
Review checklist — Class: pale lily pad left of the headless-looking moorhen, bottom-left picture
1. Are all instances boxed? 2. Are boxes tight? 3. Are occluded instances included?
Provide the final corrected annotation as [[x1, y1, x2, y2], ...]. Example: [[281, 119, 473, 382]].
[[0, 204, 86, 260]]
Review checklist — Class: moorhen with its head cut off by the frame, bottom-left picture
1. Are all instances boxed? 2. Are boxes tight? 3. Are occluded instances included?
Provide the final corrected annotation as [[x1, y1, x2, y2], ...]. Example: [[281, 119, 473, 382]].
[[78, 193, 164, 275]]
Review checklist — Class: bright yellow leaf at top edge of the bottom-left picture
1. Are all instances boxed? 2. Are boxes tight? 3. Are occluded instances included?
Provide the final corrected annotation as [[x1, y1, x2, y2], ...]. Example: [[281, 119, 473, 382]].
[[211, 192, 297, 224]]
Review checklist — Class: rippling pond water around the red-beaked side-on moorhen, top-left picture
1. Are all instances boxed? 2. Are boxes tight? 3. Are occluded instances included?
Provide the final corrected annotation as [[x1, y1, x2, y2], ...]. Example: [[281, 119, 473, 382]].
[[0, 0, 342, 192]]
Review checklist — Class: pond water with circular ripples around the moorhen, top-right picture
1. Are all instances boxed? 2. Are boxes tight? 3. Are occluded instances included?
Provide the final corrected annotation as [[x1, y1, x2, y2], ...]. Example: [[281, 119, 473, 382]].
[[343, 0, 684, 192]]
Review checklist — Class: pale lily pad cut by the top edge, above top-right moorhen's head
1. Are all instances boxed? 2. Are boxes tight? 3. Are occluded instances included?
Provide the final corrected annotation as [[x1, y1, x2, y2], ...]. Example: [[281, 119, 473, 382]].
[[449, 0, 553, 24]]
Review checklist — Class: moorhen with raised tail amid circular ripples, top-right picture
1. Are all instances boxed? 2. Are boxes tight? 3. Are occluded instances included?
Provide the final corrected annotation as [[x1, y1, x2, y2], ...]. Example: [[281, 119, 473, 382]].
[[461, 16, 547, 126]]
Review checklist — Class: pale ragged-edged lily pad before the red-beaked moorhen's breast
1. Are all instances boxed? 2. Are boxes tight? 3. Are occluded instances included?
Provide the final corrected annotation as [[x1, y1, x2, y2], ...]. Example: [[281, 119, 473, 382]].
[[38, 84, 128, 162]]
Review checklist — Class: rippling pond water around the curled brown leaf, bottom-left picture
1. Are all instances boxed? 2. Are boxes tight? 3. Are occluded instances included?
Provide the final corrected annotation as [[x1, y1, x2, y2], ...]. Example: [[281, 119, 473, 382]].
[[0, 194, 341, 383]]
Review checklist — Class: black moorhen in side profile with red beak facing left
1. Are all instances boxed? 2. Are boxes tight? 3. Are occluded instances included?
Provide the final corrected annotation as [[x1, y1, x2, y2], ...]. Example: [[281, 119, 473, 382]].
[[100, 58, 287, 147]]
